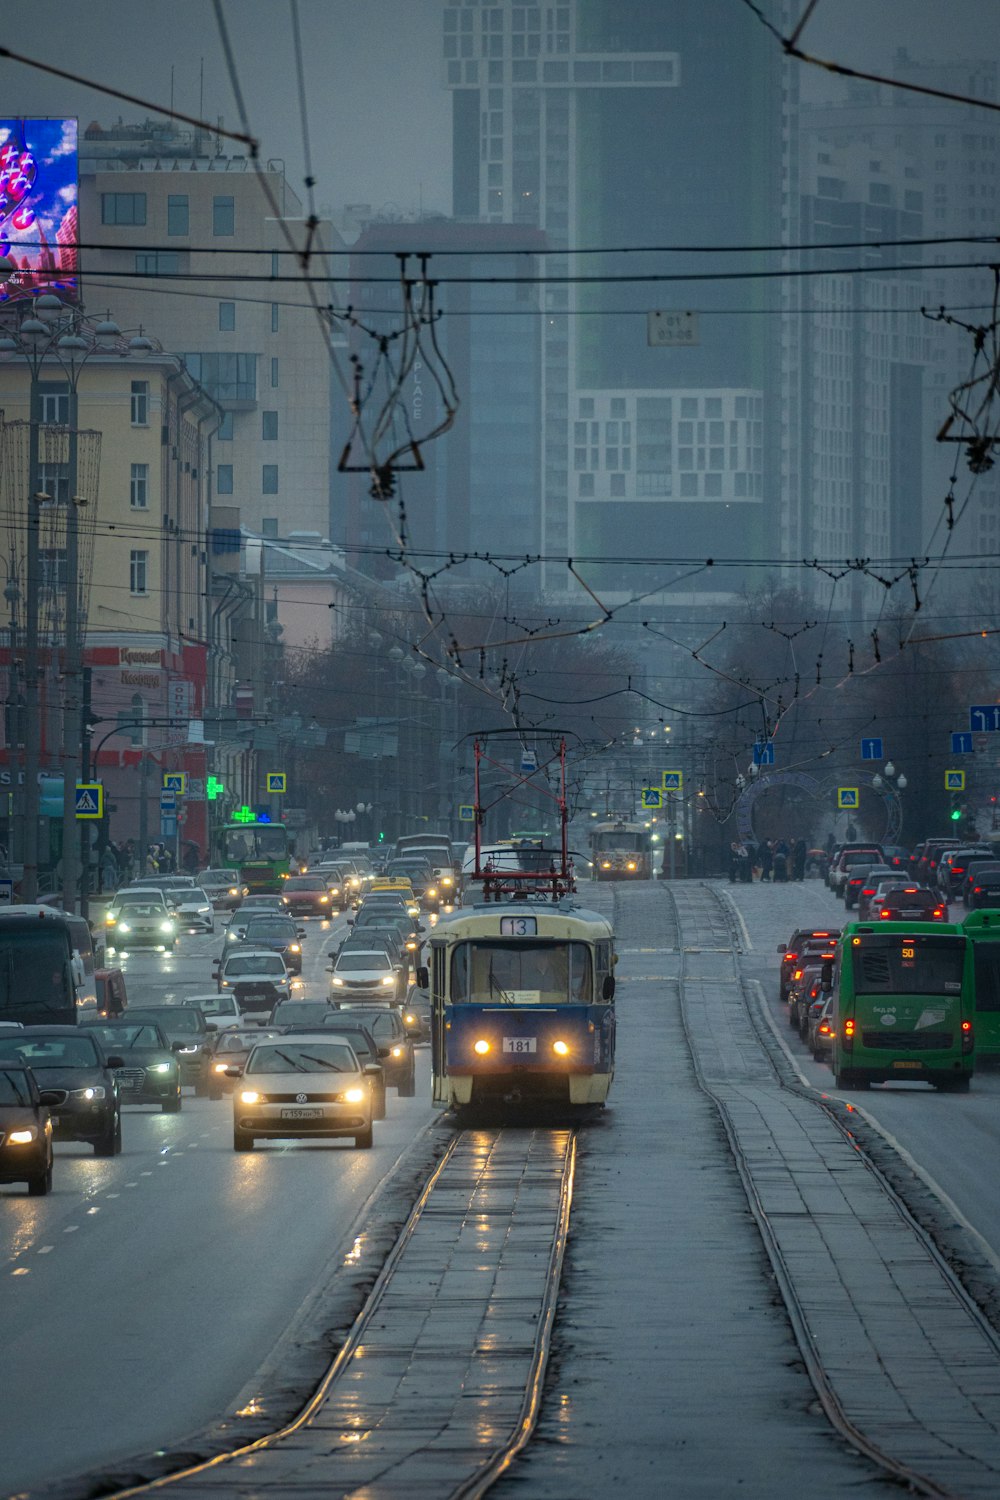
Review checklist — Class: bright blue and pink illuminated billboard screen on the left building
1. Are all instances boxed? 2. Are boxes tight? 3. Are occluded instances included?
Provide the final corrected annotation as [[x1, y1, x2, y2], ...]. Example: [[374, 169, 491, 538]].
[[0, 120, 79, 303]]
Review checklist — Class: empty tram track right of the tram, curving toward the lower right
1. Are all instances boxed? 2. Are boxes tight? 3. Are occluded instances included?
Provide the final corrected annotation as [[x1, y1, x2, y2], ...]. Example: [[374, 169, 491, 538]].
[[664, 884, 1000, 1497]]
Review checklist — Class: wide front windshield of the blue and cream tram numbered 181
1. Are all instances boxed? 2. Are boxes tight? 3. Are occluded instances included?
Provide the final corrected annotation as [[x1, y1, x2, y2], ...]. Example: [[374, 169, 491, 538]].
[[451, 941, 594, 1005]]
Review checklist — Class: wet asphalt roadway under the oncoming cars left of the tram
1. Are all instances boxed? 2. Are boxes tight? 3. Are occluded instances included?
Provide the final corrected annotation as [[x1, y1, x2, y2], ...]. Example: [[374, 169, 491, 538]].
[[0, 918, 432, 1494]]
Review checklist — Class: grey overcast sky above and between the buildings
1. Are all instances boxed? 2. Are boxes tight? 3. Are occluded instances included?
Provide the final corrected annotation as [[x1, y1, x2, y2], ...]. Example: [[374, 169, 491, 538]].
[[0, 0, 1000, 223]]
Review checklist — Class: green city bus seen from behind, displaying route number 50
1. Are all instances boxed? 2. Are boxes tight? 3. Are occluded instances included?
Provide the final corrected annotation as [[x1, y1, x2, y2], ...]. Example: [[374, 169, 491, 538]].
[[832, 923, 976, 1094]]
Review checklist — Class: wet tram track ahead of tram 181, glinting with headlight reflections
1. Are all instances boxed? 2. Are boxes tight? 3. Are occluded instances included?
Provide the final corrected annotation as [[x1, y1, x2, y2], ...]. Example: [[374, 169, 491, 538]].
[[46, 1127, 576, 1500]]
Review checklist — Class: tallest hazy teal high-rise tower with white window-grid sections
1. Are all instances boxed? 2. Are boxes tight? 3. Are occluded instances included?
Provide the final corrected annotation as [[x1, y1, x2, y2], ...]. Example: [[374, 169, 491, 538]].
[[444, 0, 789, 596]]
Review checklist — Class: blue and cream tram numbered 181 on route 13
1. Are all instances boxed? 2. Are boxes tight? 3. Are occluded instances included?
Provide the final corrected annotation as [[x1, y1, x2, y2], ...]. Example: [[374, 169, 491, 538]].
[[430, 896, 616, 1112]]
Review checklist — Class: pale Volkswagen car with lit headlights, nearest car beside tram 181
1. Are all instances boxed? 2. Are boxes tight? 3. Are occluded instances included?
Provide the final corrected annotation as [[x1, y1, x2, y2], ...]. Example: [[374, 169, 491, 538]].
[[228, 1028, 372, 1151]]
